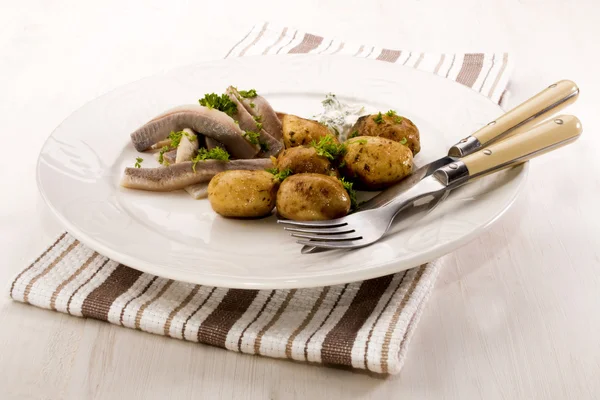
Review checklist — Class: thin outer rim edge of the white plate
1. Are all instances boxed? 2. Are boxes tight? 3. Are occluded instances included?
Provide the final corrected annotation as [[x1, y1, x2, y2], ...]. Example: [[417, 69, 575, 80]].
[[36, 54, 529, 290]]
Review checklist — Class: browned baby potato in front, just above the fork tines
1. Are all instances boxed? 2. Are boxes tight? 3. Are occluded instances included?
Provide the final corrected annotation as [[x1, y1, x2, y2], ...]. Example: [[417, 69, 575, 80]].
[[277, 174, 350, 221]]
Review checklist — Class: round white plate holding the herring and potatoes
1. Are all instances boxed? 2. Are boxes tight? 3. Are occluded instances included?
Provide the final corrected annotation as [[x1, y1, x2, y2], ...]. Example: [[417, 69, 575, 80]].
[[37, 56, 526, 289]]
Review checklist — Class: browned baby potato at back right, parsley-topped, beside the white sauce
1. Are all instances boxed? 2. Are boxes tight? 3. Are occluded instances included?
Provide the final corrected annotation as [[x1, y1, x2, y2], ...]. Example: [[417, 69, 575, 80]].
[[351, 110, 421, 156]]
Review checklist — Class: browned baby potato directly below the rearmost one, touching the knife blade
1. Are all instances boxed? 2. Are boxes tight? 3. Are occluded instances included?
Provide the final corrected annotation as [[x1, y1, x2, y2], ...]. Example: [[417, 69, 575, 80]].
[[340, 136, 413, 189]]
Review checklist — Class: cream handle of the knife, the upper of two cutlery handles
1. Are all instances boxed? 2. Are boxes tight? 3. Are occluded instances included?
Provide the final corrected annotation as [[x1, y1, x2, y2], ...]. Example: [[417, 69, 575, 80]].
[[448, 80, 579, 157]]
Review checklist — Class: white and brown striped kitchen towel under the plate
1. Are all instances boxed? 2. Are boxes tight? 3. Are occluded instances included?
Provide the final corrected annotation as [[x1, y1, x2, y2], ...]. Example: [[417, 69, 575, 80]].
[[10, 24, 510, 374]]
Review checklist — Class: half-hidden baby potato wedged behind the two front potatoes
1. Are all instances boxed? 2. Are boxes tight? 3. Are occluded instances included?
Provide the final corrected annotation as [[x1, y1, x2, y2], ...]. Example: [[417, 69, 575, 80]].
[[276, 146, 335, 175]]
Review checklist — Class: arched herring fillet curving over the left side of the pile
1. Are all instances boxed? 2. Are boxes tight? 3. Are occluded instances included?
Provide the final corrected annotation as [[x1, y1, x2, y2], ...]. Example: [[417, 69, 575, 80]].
[[131, 104, 259, 159]]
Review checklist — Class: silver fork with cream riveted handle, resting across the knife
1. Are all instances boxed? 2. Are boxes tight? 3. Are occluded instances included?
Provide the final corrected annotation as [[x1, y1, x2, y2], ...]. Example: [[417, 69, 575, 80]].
[[277, 115, 582, 249]]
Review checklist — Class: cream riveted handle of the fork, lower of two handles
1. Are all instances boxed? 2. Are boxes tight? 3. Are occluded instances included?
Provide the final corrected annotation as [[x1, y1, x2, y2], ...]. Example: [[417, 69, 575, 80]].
[[461, 115, 582, 177]]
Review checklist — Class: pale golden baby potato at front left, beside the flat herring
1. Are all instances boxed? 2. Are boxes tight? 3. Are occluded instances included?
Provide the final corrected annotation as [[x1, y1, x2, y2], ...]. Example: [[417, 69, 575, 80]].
[[208, 170, 279, 218]]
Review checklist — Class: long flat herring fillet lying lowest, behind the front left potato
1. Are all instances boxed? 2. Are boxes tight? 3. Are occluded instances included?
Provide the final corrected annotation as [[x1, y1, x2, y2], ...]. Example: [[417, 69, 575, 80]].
[[121, 158, 273, 192]]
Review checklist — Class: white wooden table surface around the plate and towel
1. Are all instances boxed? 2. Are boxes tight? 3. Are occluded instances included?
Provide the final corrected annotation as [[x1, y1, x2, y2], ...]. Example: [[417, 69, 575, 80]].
[[0, 0, 600, 399]]
